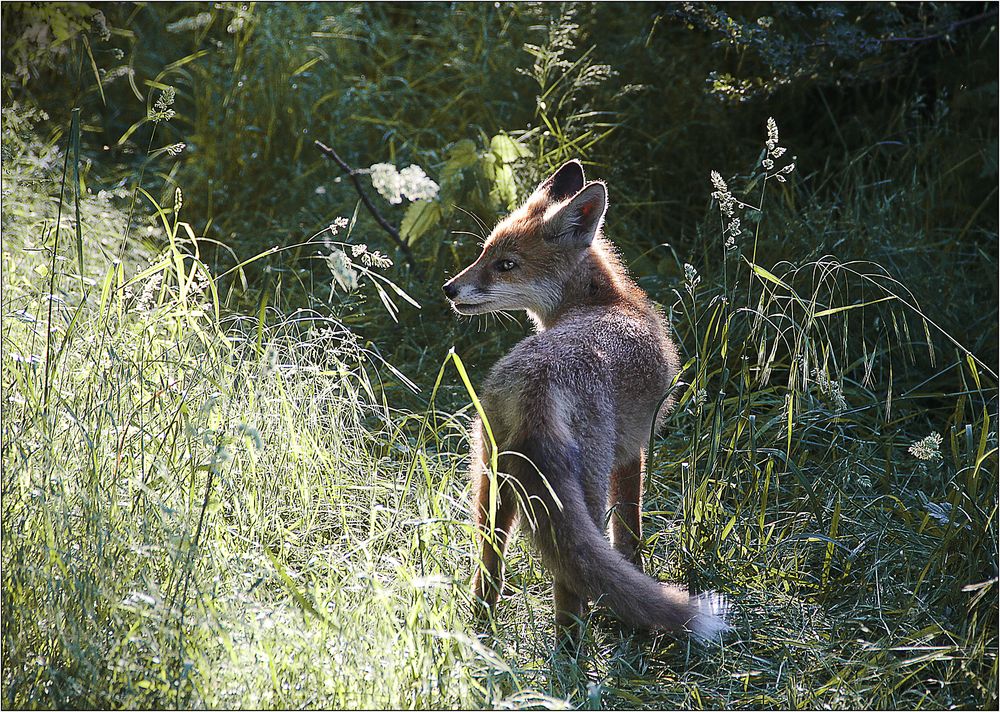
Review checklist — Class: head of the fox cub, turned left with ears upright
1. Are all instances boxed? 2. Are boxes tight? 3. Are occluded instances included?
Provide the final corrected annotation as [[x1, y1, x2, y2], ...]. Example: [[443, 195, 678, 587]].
[[444, 160, 608, 315]]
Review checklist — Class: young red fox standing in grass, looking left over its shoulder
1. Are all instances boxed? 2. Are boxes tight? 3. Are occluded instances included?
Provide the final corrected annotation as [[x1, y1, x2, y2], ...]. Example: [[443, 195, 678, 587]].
[[444, 161, 727, 643]]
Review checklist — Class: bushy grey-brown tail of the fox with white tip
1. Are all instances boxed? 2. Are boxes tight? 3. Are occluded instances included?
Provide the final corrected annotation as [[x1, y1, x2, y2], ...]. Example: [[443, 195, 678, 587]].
[[508, 434, 728, 640]]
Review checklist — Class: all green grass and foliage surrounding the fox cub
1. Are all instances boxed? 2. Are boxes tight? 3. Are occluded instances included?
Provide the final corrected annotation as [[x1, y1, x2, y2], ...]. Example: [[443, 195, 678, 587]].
[[2, 3, 998, 709]]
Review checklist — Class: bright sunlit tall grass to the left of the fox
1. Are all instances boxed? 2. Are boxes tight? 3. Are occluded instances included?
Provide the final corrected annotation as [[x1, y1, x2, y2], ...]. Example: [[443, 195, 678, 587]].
[[3, 111, 524, 707]]
